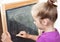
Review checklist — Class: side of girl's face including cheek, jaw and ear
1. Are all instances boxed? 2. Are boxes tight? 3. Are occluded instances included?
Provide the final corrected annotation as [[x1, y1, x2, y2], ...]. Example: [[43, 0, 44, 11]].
[[32, 15, 53, 30]]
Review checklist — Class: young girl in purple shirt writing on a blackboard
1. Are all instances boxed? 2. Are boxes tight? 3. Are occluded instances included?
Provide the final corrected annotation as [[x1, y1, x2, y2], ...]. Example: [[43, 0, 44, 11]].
[[2, 0, 60, 42]]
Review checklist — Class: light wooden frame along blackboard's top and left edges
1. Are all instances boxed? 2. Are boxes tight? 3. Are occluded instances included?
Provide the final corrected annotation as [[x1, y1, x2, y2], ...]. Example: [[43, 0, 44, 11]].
[[1, 0, 38, 32]]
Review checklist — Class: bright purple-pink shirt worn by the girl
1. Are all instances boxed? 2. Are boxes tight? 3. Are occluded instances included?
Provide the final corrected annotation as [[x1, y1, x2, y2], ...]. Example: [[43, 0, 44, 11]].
[[36, 30, 60, 42]]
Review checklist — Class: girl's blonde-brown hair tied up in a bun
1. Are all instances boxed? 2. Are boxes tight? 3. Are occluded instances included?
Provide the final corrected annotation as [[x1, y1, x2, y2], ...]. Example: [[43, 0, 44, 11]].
[[31, 0, 57, 22]]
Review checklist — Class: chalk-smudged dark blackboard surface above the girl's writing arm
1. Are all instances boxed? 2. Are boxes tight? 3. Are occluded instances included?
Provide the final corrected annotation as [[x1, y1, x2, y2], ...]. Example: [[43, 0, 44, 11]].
[[6, 3, 38, 41]]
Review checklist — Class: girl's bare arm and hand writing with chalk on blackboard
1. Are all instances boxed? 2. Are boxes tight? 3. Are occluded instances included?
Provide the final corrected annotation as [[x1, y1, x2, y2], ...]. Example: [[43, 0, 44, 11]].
[[16, 30, 41, 41]]
